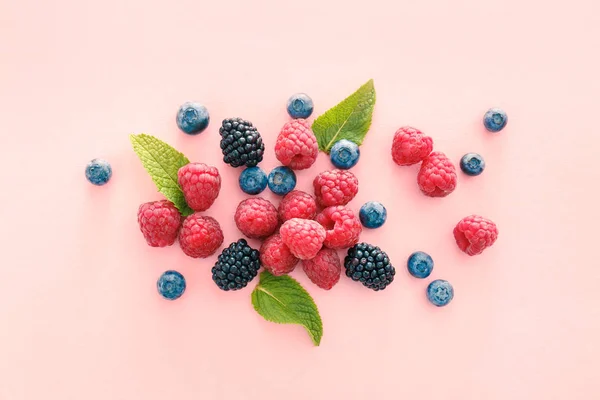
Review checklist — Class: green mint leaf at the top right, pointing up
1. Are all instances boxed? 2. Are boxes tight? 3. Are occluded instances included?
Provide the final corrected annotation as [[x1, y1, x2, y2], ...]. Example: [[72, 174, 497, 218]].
[[312, 79, 375, 153]]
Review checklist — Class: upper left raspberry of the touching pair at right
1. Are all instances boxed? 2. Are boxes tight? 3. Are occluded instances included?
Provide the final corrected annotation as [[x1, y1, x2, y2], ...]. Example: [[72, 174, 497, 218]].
[[392, 126, 433, 165]]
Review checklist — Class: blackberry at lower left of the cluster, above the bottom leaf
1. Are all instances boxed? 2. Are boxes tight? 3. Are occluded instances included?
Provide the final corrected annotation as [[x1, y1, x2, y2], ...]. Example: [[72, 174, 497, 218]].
[[212, 239, 260, 291]]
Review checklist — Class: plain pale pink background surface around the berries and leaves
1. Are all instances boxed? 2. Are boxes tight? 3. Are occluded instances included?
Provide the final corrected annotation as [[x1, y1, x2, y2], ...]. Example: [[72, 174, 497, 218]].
[[0, 0, 600, 400]]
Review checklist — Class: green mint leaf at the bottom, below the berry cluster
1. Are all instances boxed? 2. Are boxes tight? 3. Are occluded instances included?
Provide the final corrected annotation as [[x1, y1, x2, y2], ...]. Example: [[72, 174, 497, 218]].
[[252, 271, 323, 346]]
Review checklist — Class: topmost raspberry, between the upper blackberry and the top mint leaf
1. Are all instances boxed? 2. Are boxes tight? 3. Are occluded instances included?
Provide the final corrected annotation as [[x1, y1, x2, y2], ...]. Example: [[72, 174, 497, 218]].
[[275, 119, 319, 170]]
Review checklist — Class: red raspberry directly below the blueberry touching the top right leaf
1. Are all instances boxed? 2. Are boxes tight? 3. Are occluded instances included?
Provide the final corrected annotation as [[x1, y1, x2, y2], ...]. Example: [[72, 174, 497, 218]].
[[313, 169, 358, 207]]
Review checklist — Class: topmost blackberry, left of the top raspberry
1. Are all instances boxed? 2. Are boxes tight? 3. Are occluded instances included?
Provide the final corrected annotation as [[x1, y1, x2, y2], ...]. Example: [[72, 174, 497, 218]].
[[219, 118, 265, 168]]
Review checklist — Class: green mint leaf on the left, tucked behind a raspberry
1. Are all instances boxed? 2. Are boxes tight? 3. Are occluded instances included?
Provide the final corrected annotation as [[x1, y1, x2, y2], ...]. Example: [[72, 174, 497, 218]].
[[129, 134, 194, 216]]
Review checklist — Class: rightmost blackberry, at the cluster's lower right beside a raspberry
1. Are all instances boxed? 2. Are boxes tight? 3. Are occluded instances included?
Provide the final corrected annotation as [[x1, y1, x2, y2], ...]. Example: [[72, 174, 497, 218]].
[[344, 243, 396, 291]]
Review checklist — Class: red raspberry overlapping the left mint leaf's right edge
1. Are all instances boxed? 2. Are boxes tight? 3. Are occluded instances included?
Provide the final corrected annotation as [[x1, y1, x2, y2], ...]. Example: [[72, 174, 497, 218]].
[[177, 163, 221, 211]]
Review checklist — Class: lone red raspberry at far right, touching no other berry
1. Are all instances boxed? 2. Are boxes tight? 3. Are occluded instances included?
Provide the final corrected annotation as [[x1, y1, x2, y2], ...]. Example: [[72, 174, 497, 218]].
[[454, 215, 498, 256]]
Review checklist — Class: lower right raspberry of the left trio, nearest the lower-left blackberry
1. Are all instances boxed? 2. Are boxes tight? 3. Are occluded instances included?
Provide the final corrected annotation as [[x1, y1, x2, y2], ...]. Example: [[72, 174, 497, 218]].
[[179, 213, 223, 258]]
